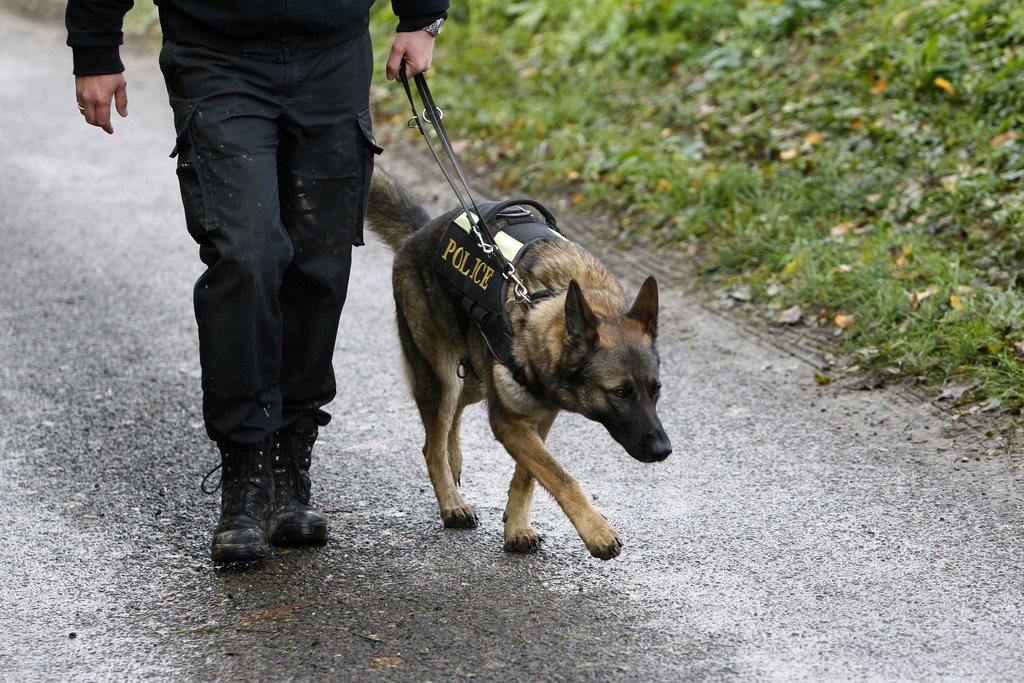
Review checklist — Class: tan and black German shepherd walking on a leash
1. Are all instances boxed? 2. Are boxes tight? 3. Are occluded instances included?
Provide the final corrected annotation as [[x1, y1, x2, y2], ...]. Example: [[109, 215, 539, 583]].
[[368, 170, 672, 560]]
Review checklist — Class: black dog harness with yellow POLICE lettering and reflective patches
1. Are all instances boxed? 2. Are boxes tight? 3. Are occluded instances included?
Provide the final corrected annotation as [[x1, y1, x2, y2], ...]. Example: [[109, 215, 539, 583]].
[[433, 199, 565, 390]]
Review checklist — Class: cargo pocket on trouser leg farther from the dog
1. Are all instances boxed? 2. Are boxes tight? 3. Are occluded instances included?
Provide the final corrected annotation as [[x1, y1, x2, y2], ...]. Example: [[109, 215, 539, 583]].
[[170, 99, 219, 242]]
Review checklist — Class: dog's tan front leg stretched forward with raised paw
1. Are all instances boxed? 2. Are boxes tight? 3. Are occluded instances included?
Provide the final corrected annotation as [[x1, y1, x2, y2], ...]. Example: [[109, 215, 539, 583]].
[[489, 409, 623, 560]]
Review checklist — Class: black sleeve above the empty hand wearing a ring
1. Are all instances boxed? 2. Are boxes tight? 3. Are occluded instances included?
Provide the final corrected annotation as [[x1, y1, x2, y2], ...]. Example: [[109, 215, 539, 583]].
[[65, 0, 135, 76]]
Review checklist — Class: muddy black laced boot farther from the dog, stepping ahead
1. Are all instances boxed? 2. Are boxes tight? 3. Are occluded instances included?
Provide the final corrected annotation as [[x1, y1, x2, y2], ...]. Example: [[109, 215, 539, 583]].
[[210, 439, 273, 563]]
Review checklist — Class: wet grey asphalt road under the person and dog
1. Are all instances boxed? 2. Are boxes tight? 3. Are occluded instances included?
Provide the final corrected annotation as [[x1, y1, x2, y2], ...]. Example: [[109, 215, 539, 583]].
[[0, 9, 1024, 681]]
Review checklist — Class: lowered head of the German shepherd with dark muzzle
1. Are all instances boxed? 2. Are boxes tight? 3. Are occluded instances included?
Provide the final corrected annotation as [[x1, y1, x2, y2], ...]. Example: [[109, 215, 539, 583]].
[[559, 278, 672, 463]]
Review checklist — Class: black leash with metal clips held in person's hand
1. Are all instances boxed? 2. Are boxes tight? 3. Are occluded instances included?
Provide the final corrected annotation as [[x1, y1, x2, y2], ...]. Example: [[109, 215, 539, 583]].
[[398, 62, 530, 304]]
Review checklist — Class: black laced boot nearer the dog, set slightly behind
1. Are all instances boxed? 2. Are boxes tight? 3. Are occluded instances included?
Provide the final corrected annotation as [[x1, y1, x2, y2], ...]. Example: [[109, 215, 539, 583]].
[[269, 417, 327, 546]]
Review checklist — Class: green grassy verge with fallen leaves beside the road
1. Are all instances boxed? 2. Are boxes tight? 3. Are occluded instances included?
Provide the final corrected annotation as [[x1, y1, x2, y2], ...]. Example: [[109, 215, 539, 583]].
[[375, 0, 1024, 415]]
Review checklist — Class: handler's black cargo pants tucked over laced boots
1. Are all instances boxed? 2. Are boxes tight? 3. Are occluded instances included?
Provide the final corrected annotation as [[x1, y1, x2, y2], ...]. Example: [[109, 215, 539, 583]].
[[160, 29, 380, 443]]
